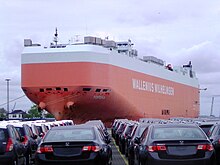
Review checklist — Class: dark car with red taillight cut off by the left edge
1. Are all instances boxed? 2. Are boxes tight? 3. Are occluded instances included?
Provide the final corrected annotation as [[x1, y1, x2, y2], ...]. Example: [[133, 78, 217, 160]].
[[0, 123, 26, 165]]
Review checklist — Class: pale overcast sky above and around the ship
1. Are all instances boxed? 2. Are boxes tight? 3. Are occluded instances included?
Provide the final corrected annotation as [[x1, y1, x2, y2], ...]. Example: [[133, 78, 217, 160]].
[[0, 0, 220, 116]]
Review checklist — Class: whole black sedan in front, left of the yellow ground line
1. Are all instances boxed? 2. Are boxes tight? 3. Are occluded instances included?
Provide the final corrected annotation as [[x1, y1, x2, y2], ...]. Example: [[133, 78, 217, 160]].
[[35, 124, 112, 165]]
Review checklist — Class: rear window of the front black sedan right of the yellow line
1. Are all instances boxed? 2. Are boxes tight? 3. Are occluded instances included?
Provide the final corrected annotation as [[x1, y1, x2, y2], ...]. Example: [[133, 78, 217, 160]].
[[152, 127, 206, 140]]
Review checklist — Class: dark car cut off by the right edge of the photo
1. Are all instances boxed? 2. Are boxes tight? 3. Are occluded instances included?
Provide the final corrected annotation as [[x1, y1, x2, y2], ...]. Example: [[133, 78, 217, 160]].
[[208, 123, 220, 164]]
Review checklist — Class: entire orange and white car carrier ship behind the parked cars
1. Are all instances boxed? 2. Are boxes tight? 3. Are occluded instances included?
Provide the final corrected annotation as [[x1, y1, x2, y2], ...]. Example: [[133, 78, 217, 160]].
[[21, 32, 199, 123]]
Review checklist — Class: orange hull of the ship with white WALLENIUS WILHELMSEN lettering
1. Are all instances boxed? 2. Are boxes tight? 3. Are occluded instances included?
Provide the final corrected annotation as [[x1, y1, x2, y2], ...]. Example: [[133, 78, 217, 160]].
[[21, 62, 199, 123]]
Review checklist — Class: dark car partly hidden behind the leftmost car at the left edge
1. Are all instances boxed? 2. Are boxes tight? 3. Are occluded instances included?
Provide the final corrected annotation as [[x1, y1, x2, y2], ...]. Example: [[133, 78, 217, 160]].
[[13, 123, 38, 165]]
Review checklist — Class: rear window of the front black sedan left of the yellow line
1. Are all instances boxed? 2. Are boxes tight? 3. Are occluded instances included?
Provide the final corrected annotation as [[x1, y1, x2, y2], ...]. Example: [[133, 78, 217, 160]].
[[44, 129, 95, 142]]
